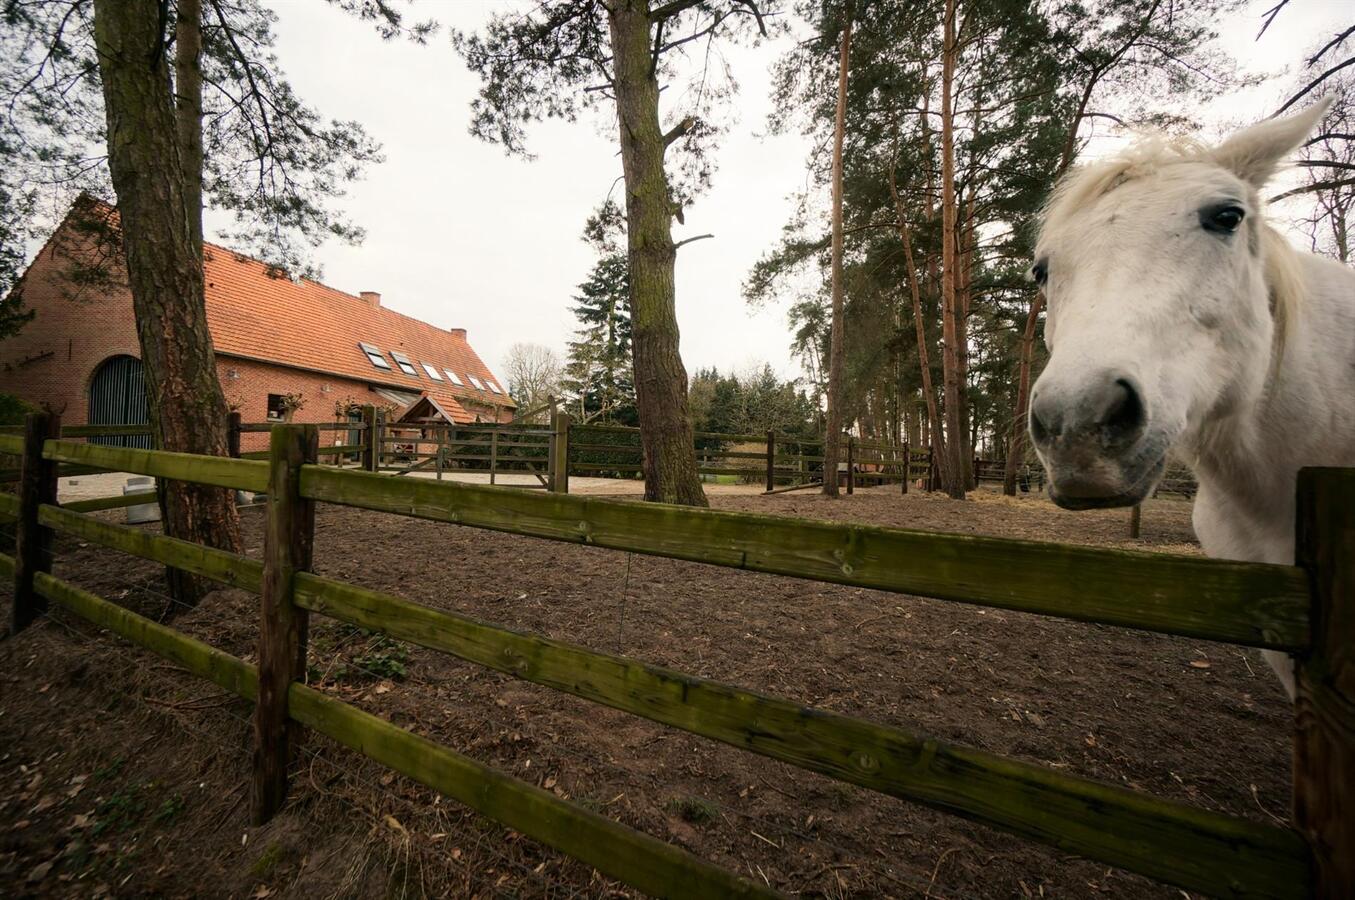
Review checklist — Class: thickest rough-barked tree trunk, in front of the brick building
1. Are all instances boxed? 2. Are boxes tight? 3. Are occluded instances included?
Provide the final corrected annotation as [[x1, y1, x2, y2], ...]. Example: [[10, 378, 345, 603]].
[[95, 0, 241, 605]]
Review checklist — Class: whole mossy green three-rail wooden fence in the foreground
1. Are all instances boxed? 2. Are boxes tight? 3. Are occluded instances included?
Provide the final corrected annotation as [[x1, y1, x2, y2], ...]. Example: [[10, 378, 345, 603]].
[[0, 415, 1355, 900]]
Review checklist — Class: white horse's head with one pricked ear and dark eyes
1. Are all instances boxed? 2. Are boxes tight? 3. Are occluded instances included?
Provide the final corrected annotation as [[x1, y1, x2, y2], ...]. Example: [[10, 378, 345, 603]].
[[1030, 100, 1329, 510]]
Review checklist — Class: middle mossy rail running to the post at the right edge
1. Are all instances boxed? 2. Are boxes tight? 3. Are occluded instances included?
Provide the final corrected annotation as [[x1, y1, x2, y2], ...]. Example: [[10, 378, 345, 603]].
[[297, 573, 1308, 897]]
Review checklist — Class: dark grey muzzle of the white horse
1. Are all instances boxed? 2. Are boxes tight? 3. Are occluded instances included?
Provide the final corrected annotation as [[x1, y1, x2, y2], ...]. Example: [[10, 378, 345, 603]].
[[1030, 370, 1167, 510]]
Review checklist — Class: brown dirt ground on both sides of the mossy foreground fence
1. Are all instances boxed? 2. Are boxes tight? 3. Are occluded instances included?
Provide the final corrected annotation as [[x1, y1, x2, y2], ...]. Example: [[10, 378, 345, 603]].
[[0, 488, 1290, 899]]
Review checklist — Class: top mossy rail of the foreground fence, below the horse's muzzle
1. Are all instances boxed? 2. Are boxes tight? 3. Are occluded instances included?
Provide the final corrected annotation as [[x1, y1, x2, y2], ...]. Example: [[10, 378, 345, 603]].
[[301, 466, 1310, 651]]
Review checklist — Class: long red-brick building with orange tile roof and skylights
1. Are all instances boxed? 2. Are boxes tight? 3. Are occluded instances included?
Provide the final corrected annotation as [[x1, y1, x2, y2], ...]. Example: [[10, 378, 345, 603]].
[[0, 197, 516, 439]]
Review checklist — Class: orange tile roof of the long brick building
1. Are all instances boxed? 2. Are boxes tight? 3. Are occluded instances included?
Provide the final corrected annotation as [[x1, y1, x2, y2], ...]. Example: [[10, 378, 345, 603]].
[[205, 244, 516, 422]]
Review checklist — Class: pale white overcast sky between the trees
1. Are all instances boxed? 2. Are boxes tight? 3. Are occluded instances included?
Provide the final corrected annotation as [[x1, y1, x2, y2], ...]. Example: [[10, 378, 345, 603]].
[[207, 0, 1351, 377]]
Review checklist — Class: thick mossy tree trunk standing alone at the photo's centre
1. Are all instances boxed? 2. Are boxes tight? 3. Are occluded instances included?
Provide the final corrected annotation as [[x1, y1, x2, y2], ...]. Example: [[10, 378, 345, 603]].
[[607, 0, 707, 506]]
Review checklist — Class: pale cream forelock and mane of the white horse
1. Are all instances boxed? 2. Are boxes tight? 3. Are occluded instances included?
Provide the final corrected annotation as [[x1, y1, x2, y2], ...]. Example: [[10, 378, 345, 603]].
[[1041, 133, 1305, 375]]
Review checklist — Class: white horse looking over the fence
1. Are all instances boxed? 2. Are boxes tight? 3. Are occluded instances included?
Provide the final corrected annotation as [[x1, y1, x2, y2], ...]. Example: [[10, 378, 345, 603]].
[[1030, 100, 1355, 697]]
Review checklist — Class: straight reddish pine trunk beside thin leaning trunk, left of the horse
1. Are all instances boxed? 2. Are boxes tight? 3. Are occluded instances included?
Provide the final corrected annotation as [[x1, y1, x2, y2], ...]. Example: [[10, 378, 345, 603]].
[[940, 0, 965, 500]]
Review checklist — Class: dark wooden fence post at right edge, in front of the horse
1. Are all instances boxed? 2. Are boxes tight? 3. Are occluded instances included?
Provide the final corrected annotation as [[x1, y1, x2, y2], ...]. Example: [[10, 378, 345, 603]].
[[1294, 469, 1355, 900]]
